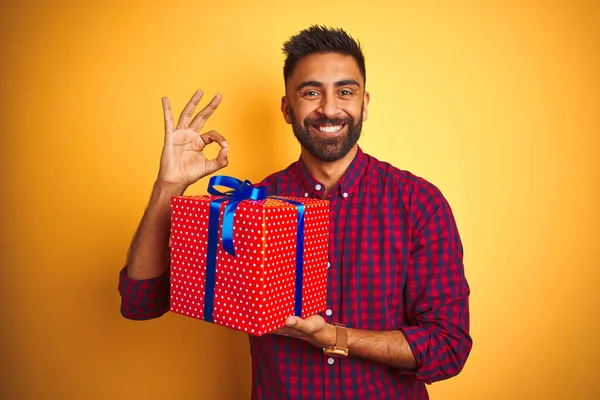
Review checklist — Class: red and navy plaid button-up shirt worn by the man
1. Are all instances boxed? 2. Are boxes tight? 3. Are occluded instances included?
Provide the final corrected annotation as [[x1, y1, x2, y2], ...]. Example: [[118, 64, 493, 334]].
[[119, 148, 472, 400]]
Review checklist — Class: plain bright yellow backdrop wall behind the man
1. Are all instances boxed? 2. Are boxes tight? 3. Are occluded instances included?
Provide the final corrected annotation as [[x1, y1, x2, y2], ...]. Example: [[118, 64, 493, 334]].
[[0, 0, 600, 400]]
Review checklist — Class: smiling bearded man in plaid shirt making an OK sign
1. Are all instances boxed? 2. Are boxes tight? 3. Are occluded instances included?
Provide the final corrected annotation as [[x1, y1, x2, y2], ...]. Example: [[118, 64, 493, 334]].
[[119, 26, 472, 399]]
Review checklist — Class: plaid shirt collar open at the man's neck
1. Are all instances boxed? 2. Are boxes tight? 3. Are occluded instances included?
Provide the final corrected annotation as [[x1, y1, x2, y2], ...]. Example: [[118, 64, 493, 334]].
[[295, 146, 369, 200]]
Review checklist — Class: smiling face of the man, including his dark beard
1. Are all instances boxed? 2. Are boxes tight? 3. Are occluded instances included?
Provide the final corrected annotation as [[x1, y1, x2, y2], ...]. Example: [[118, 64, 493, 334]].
[[281, 53, 369, 162]]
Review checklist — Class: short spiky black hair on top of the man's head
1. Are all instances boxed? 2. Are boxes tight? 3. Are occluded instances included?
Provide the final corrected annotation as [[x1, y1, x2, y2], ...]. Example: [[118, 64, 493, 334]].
[[283, 25, 367, 84]]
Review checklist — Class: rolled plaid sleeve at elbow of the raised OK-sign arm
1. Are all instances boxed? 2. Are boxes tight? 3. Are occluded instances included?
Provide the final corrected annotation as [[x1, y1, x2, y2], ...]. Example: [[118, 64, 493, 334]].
[[119, 266, 170, 320]]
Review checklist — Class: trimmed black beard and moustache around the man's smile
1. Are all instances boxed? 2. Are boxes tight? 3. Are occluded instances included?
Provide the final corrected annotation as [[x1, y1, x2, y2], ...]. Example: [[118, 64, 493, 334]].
[[290, 103, 364, 162]]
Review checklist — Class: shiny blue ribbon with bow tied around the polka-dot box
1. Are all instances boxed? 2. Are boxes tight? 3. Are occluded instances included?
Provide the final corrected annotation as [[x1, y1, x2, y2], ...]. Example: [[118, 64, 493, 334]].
[[204, 176, 305, 322]]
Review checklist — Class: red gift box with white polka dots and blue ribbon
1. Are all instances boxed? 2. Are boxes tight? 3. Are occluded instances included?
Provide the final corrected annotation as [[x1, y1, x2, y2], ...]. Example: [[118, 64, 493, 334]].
[[170, 177, 329, 336]]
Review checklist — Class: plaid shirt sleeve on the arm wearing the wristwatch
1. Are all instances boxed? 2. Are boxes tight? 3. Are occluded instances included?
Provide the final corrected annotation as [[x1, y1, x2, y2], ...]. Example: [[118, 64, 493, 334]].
[[401, 181, 472, 383]]
